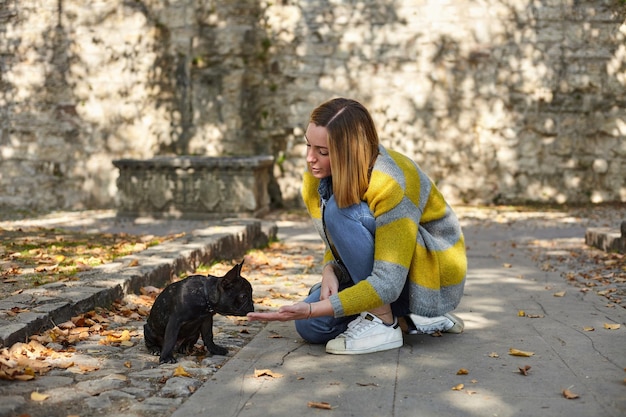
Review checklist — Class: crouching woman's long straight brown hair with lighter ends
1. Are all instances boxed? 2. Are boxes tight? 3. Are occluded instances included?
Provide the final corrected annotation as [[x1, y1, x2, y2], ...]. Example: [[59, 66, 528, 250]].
[[309, 98, 378, 208]]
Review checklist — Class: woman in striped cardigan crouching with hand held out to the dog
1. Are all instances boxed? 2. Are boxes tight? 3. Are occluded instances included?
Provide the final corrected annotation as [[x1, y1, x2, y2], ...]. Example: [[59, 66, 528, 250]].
[[248, 98, 467, 354]]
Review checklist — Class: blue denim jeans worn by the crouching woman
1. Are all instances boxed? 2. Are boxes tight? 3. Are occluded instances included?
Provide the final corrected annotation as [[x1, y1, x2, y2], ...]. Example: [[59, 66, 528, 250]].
[[295, 197, 409, 343]]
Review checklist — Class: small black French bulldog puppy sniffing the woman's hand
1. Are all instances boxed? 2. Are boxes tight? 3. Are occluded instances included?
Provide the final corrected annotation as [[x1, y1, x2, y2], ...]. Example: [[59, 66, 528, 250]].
[[143, 261, 254, 364]]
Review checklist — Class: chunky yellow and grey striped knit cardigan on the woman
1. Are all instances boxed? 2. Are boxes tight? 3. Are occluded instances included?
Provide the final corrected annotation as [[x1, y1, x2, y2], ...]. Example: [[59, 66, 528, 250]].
[[302, 146, 467, 317]]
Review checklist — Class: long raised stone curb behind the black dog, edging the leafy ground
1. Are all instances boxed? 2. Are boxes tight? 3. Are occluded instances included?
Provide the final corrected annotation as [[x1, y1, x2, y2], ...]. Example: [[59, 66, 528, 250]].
[[0, 219, 278, 348]]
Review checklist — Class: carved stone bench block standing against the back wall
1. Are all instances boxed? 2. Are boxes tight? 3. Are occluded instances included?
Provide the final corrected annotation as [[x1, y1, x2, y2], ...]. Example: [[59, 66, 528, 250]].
[[113, 156, 273, 219]]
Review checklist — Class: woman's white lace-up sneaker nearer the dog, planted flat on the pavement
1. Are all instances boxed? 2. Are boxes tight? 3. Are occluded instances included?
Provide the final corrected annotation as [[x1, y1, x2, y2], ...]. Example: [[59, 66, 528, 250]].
[[326, 311, 403, 355]]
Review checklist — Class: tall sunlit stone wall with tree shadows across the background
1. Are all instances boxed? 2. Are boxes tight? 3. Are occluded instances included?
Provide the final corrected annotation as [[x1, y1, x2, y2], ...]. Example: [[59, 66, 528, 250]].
[[0, 0, 626, 214]]
